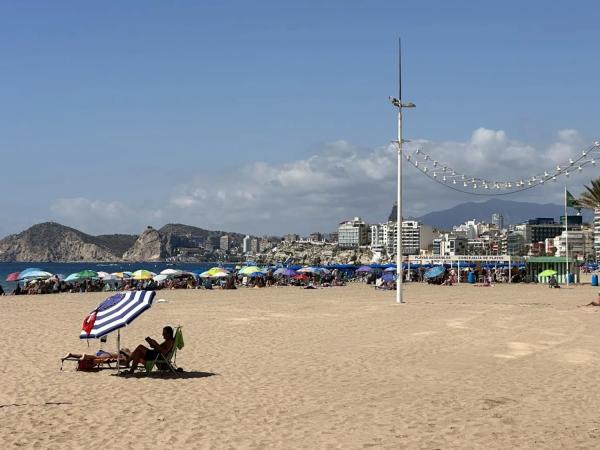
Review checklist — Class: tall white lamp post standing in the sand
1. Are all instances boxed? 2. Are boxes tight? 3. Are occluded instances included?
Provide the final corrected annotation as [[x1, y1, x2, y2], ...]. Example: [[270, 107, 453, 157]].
[[390, 41, 416, 303]]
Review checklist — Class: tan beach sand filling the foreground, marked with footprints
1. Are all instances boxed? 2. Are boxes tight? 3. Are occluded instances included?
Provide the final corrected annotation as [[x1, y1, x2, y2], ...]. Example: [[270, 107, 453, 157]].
[[0, 284, 600, 449]]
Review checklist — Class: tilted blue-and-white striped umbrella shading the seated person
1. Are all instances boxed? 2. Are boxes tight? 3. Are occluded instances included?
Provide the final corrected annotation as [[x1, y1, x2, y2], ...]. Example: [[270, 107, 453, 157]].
[[79, 291, 155, 339]]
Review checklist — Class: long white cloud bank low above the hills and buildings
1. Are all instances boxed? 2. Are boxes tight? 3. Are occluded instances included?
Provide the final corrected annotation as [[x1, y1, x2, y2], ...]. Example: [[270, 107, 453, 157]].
[[44, 128, 592, 234]]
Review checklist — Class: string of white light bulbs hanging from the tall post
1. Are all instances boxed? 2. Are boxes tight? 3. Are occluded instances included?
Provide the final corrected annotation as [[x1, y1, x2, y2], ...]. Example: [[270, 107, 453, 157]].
[[396, 141, 600, 196]]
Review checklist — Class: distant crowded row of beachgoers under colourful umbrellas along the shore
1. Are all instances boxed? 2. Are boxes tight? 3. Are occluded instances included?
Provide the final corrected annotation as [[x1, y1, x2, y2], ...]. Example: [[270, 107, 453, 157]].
[[0, 264, 598, 295]]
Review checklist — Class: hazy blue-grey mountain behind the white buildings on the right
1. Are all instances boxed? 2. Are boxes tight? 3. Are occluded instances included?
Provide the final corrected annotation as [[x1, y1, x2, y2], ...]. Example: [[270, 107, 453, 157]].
[[406, 199, 592, 229]]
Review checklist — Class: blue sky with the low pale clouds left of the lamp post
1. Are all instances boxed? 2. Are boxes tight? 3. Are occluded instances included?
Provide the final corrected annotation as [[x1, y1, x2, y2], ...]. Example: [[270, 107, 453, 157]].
[[0, 1, 600, 235]]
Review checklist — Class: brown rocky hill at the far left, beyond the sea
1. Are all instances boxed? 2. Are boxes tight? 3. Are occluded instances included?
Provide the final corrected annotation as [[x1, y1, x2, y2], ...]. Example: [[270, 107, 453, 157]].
[[0, 222, 123, 262]]
